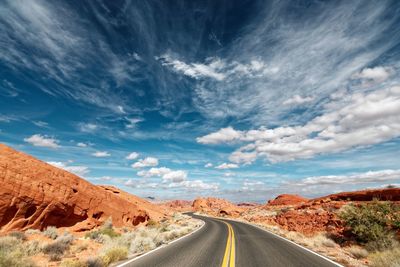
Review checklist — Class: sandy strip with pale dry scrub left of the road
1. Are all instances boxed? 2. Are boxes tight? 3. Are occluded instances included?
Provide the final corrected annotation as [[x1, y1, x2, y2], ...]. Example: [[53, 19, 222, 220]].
[[0, 214, 200, 267]]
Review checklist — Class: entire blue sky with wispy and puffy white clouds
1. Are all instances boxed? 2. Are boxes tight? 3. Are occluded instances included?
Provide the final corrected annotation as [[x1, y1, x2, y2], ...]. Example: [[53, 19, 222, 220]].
[[0, 0, 400, 202]]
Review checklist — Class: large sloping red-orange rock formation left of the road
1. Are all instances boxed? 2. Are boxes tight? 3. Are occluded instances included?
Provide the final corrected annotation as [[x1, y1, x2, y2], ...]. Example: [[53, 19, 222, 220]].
[[0, 144, 168, 231]]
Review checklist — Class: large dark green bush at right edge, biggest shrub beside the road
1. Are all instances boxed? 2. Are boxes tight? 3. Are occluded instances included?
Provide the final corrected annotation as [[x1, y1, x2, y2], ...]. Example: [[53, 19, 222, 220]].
[[339, 200, 398, 250]]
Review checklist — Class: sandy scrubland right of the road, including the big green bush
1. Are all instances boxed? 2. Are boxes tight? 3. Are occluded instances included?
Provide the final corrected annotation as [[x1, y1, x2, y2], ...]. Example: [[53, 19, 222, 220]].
[[230, 199, 400, 267]]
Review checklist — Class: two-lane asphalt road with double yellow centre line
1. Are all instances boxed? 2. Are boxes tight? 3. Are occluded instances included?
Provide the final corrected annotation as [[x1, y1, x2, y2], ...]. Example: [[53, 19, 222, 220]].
[[120, 215, 340, 267]]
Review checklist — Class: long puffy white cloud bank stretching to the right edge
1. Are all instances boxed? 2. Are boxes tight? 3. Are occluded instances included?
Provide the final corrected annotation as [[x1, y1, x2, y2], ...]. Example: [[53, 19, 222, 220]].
[[197, 86, 400, 163]]
